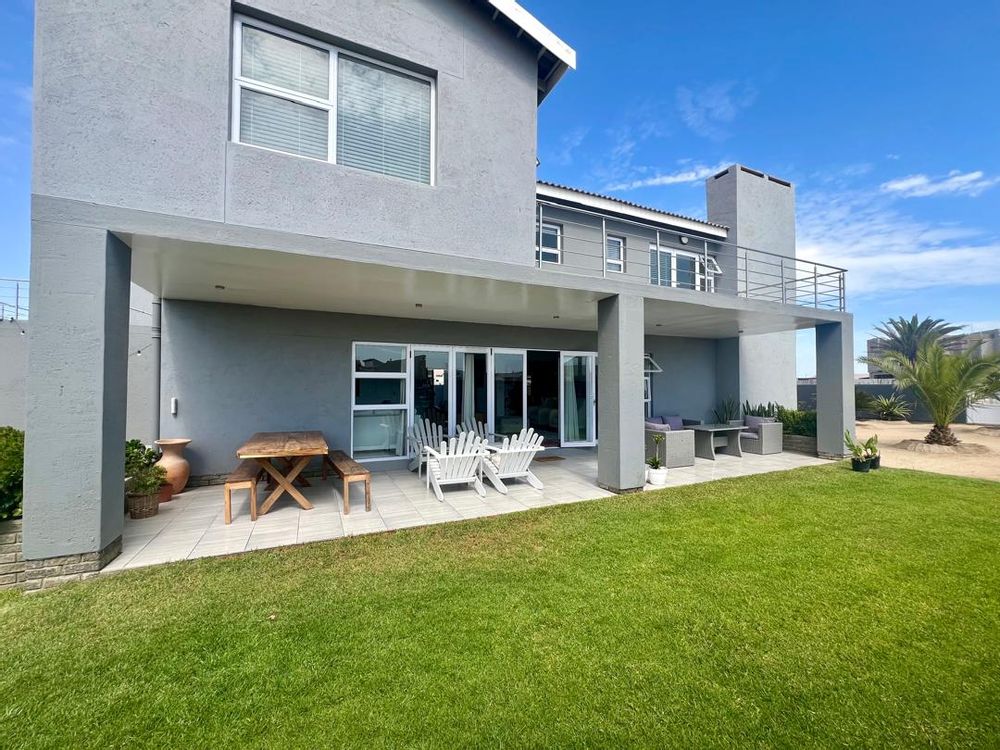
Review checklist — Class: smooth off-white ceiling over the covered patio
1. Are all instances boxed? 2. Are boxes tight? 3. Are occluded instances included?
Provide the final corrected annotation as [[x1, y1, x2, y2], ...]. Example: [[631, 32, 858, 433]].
[[130, 235, 836, 338]]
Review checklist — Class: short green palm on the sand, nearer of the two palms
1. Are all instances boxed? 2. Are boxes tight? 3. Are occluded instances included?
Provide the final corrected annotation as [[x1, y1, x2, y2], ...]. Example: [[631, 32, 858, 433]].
[[873, 341, 1000, 445]]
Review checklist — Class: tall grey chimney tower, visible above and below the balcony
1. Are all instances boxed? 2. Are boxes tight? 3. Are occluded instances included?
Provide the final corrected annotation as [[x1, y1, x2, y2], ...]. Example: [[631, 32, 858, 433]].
[[705, 165, 797, 407]]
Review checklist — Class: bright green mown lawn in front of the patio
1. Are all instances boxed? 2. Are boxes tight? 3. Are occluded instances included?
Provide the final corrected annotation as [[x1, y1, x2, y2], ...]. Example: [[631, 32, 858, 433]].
[[0, 465, 1000, 748]]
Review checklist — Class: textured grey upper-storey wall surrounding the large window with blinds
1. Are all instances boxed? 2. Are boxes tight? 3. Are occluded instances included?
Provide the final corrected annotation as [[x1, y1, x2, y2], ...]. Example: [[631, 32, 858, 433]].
[[33, 0, 537, 264]]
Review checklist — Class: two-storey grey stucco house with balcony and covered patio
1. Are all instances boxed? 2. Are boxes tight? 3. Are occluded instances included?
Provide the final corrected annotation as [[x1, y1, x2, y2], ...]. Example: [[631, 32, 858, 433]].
[[24, 0, 853, 572]]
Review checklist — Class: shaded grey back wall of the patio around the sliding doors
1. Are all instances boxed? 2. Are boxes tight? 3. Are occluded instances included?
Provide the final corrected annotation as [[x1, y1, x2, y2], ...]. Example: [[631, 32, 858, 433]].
[[160, 300, 728, 474]]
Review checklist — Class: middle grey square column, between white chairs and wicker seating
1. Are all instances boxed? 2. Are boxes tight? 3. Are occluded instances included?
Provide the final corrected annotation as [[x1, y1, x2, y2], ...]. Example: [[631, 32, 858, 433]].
[[597, 295, 646, 492]]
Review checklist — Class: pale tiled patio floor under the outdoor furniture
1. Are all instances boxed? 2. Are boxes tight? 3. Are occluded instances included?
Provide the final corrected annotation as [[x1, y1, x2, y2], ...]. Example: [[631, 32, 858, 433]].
[[104, 448, 825, 572]]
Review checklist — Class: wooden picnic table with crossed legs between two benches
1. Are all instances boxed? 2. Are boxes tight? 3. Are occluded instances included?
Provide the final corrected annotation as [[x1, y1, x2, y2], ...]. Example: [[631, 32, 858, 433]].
[[236, 430, 330, 514]]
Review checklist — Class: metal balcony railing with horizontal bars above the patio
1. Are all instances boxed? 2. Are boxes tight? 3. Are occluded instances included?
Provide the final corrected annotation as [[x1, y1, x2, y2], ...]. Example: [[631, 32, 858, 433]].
[[536, 201, 847, 311]]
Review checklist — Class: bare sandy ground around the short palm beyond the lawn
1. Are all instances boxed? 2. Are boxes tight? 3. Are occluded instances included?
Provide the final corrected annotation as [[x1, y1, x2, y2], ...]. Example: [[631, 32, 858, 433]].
[[857, 420, 1000, 482]]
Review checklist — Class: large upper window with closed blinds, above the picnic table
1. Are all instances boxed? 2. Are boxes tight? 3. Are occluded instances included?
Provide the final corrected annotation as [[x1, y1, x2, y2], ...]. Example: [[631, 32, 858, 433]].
[[233, 18, 434, 184]]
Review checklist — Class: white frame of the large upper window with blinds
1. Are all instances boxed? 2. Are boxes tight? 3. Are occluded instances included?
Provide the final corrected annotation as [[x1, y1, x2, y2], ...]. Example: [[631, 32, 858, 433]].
[[236, 14, 437, 187]]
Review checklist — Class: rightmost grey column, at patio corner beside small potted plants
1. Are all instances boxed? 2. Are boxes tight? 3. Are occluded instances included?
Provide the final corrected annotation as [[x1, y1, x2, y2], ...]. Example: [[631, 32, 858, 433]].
[[816, 320, 854, 458]]
